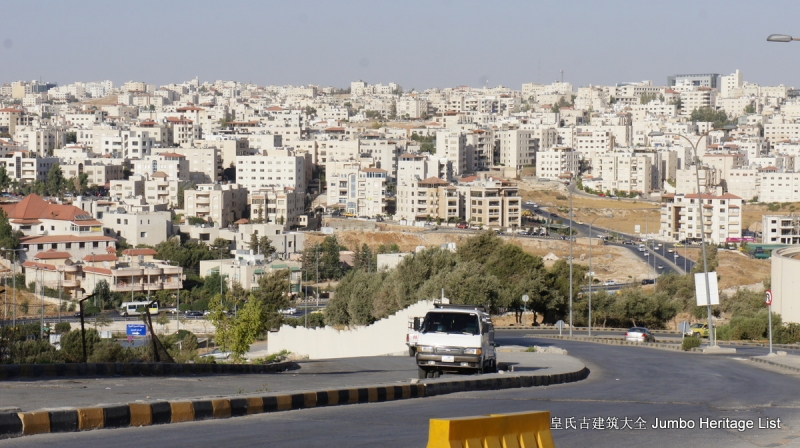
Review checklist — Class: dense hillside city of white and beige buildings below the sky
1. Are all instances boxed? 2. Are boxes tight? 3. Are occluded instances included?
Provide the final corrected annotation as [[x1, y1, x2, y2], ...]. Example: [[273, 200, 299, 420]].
[[0, 70, 800, 360]]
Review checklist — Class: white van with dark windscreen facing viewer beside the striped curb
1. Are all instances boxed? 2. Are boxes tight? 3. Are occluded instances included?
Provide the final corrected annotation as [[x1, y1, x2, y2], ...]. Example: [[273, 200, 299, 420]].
[[416, 304, 497, 379]]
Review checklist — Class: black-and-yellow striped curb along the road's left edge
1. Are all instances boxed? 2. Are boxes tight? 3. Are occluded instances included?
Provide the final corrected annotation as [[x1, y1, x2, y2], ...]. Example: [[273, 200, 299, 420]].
[[0, 367, 589, 439]]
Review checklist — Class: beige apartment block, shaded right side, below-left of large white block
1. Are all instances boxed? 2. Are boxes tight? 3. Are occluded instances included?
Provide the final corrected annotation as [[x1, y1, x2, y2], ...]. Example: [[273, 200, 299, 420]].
[[183, 184, 247, 227]]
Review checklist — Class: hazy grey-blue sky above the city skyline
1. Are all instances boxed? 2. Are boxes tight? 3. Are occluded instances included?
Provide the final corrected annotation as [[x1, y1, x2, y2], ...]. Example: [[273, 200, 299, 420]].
[[0, 0, 800, 90]]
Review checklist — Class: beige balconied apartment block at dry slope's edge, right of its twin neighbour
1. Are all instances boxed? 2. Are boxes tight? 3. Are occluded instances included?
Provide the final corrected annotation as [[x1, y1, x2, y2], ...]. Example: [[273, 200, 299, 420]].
[[456, 174, 522, 228]]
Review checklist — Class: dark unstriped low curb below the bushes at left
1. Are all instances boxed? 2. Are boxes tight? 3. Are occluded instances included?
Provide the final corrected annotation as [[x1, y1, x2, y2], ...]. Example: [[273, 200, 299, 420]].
[[0, 361, 298, 381]]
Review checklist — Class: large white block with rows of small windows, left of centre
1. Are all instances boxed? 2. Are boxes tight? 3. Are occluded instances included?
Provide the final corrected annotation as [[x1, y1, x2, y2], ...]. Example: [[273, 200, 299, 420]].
[[236, 149, 306, 191]]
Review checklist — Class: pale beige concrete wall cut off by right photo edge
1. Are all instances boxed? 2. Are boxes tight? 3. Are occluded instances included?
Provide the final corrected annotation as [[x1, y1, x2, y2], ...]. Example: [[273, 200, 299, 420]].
[[770, 246, 800, 323]]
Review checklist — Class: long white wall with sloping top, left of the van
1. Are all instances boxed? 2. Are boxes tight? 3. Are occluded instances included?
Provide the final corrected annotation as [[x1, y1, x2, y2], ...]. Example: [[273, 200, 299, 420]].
[[269, 301, 433, 359]]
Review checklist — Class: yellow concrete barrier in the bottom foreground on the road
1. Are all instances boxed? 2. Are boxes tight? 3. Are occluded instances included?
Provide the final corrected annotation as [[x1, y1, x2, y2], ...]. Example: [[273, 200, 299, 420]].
[[428, 411, 555, 448]]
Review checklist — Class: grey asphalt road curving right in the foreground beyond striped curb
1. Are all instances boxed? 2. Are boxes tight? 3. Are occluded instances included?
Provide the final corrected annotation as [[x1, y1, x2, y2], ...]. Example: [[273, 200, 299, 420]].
[[9, 331, 800, 448]]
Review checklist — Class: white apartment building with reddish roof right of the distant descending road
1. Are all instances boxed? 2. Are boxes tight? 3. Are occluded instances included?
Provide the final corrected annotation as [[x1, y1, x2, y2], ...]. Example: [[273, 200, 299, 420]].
[[659, 193, 742, 244]]
